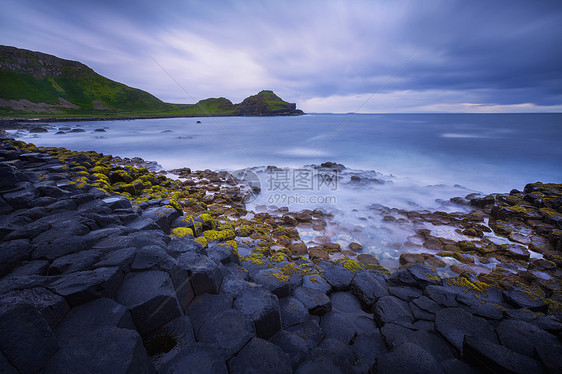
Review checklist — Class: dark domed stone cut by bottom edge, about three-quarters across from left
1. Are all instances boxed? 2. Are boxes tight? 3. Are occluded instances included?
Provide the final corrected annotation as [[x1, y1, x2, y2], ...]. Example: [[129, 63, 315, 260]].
[[373, 342, 443, 374]]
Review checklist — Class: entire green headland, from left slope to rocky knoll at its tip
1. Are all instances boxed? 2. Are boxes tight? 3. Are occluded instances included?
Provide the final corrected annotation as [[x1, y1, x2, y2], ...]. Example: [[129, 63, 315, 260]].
[[0, 46, 303, 118]]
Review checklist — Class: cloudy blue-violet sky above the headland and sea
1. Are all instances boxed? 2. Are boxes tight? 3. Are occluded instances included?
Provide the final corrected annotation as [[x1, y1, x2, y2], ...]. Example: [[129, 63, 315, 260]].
[[0, 0, 562, 113]]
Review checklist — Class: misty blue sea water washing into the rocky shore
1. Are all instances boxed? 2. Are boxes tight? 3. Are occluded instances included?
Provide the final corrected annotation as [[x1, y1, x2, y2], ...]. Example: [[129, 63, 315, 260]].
[[9, 114, 562, 270]]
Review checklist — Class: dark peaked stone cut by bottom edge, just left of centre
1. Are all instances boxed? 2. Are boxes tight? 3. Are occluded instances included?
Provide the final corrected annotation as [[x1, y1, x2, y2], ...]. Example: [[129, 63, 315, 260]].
[[228, 338, 293, 374]]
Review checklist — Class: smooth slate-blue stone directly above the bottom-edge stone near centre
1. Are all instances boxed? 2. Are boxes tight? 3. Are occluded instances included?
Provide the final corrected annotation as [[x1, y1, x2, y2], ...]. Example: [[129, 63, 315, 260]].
[[234, 288, 281, 339]]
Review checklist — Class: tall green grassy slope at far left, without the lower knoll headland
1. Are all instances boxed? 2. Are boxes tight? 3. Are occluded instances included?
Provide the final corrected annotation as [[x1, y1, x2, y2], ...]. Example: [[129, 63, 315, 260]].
[[0, 46, 178, 115]]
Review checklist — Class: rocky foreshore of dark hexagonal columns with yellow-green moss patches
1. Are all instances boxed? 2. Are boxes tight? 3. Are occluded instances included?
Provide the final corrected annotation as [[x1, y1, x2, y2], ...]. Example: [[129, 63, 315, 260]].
[[0, 138, 562, 374]]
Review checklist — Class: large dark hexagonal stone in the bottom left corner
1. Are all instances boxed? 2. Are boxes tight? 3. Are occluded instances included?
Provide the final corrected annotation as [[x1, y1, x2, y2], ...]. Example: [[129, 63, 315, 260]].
[[0, 300, 59, 373]]
